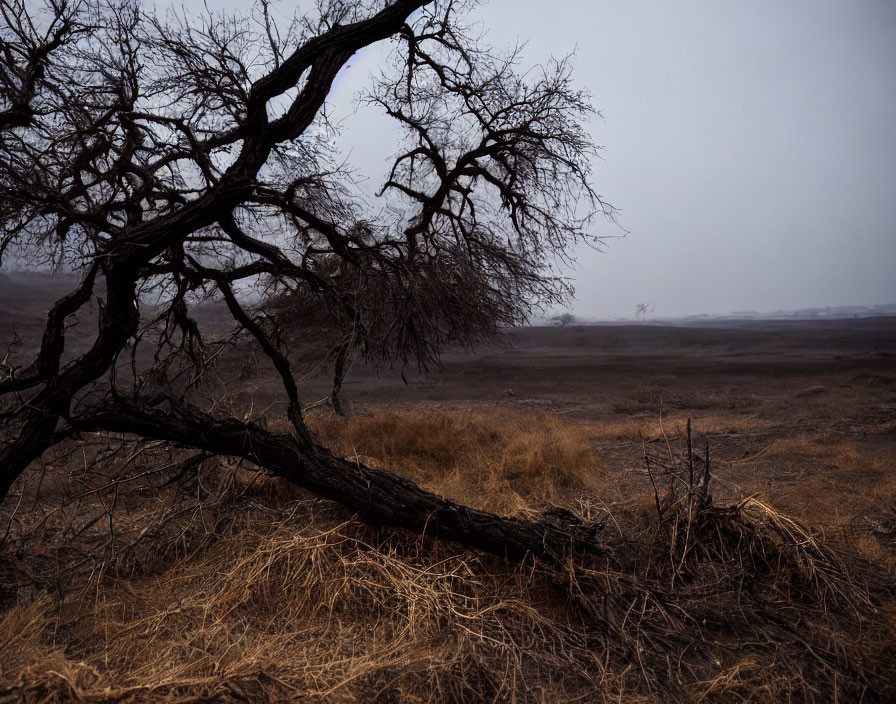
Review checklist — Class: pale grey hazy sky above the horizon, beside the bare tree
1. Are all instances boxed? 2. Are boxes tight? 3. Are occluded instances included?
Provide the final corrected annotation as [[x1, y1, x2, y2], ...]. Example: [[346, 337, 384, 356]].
[[203, 0, 896, 317]]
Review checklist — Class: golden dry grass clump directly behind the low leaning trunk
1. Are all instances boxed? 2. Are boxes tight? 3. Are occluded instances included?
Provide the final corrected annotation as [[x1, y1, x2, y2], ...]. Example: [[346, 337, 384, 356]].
[[313, 407, 605, 514]]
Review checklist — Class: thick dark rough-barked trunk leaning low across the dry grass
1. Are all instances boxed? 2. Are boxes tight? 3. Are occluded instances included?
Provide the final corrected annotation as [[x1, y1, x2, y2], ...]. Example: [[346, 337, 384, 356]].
[[76, 402, 603, 563]]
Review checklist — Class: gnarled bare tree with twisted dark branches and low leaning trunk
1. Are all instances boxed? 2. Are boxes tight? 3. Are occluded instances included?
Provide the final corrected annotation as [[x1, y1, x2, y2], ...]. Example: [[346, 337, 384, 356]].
[[0, 0, 606, 559]]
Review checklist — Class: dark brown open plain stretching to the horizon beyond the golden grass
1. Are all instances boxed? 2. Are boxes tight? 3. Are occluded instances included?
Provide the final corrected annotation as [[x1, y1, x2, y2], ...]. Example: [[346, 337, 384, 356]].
[[0, 274, 896, 523]]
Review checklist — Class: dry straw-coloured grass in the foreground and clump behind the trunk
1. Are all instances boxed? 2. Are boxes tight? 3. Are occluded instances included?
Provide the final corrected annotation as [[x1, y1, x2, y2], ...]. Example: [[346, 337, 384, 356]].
[[0, 408, 896, 703]]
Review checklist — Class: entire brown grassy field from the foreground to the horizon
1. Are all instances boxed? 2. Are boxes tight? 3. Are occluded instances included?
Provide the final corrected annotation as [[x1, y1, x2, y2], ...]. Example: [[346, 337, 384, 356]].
[[0, 280, 896, 702]]
